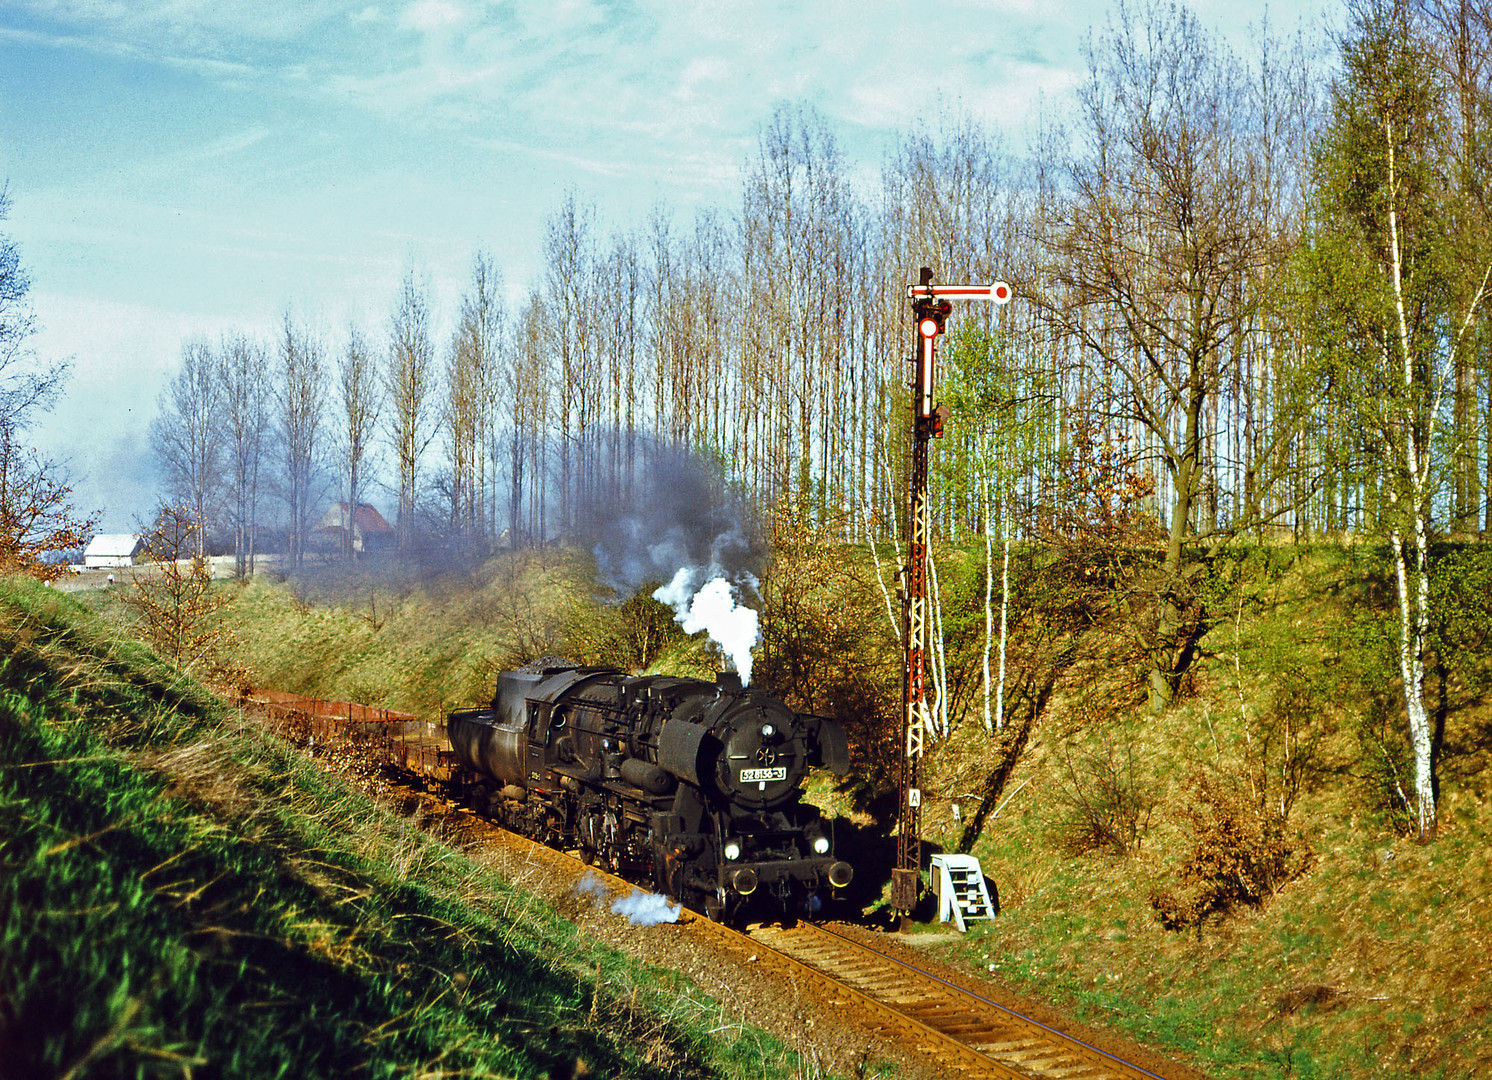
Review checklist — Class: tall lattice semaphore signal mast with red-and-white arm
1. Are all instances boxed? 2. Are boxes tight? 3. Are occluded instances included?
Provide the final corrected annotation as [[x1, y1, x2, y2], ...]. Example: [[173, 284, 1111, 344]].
[[891, 267, 1010, 925]]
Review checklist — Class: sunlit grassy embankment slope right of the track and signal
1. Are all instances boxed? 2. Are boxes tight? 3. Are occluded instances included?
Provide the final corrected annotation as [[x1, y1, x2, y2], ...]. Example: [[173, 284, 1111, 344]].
[[928, 549, 1492, 1080]]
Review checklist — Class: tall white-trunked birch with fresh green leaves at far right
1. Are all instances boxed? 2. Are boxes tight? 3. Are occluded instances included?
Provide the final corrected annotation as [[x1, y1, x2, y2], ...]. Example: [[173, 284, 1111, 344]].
[[1307, 0, 1492, 840]]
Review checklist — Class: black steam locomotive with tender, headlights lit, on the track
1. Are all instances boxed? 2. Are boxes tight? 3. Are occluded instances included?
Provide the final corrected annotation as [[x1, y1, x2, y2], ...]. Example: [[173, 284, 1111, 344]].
[[446, 665, 853, 919]]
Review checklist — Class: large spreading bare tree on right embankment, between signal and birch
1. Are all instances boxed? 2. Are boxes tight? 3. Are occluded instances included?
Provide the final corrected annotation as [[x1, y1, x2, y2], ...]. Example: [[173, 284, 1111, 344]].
[[1024, 0, 1298, 709]]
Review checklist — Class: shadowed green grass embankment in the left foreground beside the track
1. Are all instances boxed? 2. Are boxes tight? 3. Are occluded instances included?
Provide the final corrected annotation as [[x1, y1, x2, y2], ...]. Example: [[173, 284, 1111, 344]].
[[0, 569, 795, 1080]]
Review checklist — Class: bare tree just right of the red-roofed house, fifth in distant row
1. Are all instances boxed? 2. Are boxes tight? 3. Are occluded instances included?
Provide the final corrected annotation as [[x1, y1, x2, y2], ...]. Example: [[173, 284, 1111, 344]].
[[383, 267, 436, 549]]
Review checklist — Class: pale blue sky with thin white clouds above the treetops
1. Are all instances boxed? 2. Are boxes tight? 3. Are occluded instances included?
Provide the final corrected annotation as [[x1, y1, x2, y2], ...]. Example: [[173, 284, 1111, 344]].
[[0, 0, 1334, 531]]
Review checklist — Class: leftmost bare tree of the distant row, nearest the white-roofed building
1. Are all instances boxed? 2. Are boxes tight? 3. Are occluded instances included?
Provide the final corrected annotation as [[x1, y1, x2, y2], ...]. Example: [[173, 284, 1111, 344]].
[[151, 339, 224, 558]]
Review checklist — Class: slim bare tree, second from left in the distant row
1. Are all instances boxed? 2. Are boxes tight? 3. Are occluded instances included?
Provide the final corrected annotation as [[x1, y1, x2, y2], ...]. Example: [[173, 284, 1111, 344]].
[[218, 334, 270, 577]]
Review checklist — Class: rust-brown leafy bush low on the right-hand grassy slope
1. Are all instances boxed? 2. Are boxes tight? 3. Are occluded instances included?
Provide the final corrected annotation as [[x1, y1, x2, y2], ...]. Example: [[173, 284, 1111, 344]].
[[1150, 773, 1313, 929]]
